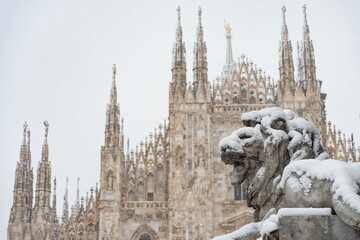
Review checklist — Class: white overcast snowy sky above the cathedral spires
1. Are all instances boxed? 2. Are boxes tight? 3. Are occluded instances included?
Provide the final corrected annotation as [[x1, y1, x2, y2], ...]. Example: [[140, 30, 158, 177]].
[[0, 0, 360, 236]]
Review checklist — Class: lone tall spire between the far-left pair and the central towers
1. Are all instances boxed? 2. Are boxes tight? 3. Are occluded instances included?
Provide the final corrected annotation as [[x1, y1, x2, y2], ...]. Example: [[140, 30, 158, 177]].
[[105, 64, 120, 146]]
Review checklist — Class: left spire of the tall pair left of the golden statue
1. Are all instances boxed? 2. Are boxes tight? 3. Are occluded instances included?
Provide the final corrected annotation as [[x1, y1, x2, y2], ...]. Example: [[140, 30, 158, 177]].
[[171, 7, 186, 95]]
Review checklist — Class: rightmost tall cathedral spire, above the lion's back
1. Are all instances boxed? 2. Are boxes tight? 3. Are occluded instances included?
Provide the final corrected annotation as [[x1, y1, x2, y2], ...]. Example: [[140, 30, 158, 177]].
[[298, 5, 316, 86]]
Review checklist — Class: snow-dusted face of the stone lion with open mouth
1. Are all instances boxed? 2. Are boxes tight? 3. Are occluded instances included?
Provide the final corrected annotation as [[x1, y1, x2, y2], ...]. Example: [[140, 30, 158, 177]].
[[220, 127, 264, 185]]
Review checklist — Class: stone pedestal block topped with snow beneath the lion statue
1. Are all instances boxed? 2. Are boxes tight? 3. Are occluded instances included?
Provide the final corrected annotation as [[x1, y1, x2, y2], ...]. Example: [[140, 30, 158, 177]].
[[278, 208, 360, 240]]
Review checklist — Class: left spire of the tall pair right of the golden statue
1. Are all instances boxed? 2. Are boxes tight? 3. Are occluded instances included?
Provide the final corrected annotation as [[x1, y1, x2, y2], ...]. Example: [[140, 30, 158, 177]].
[[279, 6, 295, 86]]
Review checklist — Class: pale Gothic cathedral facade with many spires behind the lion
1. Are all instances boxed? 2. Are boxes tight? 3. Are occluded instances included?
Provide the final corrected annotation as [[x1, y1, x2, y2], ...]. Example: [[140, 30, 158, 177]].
[[8, 6, 359, 240]]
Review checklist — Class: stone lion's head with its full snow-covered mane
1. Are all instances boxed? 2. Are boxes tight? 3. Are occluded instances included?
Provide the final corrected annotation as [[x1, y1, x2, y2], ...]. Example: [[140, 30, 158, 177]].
[[219, 108, 329, 220]]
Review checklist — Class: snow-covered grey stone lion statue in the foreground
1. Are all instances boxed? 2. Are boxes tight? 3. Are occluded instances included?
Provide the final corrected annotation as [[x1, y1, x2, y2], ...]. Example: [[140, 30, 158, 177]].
[[219, 108, 360, 229]]
